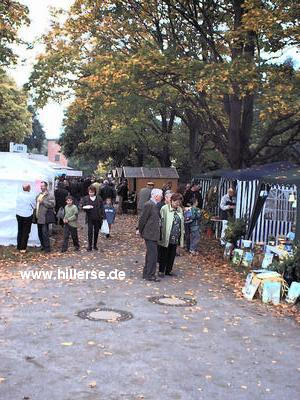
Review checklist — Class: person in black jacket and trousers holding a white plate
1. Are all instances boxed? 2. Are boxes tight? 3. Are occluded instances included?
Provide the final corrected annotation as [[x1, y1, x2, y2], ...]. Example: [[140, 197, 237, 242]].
[[82, 185, 106, 251]]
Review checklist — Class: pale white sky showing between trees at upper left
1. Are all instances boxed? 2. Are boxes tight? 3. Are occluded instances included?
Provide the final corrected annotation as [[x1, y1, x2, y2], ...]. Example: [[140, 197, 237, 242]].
[[8, 0, 74, 139]]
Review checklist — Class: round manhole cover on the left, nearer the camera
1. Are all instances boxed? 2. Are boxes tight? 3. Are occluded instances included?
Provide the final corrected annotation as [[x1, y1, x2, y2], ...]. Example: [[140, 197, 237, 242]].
[[76, 308, 133, 322]]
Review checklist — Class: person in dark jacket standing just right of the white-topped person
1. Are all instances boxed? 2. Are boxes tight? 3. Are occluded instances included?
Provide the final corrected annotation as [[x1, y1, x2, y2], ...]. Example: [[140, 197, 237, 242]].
[[36, 182, 55, 253]]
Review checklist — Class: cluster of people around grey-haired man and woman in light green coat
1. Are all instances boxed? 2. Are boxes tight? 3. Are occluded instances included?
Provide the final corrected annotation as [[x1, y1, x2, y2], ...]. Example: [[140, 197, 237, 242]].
[[137, 182, 203, 282]]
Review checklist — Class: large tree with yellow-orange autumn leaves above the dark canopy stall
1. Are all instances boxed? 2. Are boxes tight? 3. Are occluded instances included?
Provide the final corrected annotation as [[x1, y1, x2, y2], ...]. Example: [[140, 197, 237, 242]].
[[31, 0, 300, 168]]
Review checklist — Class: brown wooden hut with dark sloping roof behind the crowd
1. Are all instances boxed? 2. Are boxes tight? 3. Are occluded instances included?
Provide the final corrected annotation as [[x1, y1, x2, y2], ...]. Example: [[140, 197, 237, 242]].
[[122, 167, 179, 193]]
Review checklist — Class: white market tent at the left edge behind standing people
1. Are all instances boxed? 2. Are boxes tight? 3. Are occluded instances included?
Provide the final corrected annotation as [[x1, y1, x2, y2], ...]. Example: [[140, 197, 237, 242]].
[[0, 152, 55, 246]]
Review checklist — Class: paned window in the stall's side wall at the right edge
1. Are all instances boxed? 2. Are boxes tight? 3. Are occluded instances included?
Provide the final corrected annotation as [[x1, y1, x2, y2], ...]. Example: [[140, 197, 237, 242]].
[[264, 189, 296, 222]]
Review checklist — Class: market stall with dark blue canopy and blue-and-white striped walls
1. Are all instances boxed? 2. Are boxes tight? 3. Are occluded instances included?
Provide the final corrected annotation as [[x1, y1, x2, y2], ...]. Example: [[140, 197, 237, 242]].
[[195, 161, 299, 242]]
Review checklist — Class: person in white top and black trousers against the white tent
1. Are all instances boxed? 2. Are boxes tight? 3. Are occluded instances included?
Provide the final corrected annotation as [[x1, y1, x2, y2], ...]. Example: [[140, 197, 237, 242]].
[[16, 184, 35, 253]]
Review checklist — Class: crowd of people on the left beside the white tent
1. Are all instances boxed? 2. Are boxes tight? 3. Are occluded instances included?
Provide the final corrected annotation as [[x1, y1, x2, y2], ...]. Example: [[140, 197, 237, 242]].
[[16, 176, 122, 253]]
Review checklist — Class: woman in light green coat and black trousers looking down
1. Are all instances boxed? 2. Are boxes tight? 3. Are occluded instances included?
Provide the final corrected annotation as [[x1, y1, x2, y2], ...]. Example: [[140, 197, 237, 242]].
[[159, 193, 184, 276]]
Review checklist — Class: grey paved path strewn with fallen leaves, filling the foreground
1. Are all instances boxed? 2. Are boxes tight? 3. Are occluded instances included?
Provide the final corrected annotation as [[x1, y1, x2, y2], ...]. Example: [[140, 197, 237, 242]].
[[0, 218, 300, 400]]
